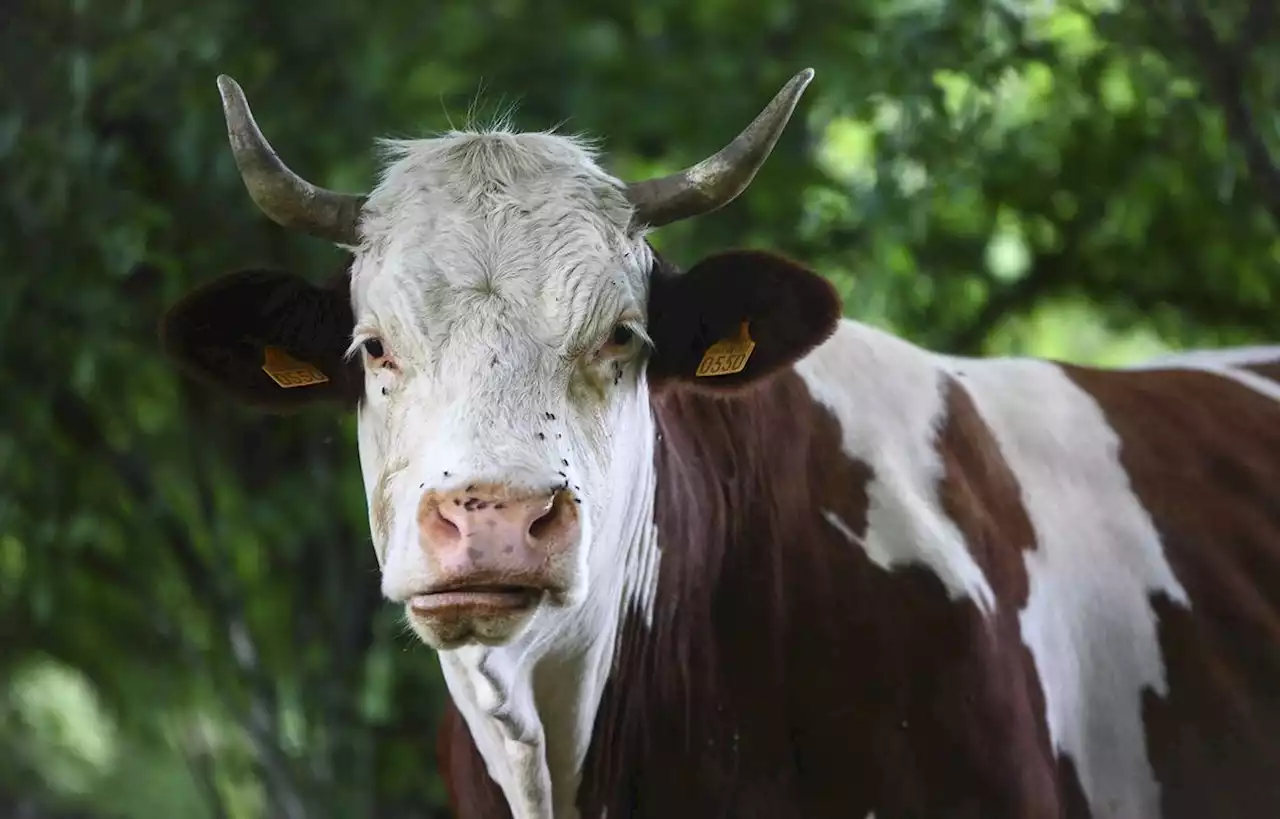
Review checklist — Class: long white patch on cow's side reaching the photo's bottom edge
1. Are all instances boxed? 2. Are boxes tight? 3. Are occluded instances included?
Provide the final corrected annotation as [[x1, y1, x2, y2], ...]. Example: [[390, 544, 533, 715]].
[[940, 357, 1190, 819]]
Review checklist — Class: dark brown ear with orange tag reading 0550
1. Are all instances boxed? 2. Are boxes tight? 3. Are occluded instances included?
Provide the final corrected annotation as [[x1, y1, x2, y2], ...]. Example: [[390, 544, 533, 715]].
[[648, 251, 841, 390]]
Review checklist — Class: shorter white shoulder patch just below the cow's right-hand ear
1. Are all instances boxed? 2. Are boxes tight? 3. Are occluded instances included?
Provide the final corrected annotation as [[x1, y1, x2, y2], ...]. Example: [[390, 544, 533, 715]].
[[795, 320, 996, 614]]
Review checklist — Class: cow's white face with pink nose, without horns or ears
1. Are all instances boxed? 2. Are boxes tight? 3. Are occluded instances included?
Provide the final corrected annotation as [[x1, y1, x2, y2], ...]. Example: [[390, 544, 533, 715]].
[[352, 133, 653, 649]]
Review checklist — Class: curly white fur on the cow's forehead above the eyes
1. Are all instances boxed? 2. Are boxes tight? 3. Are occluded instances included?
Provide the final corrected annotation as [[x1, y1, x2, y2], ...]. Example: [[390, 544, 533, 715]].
[[352, 128, 652, 355]]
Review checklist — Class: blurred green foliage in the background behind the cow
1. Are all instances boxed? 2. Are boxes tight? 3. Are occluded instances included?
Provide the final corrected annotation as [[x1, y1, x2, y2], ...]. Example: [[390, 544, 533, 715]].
[[0, 0, 1280, 819]]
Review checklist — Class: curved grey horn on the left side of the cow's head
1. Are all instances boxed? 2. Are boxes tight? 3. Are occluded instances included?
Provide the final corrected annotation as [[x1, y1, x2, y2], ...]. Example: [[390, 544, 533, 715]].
[[218, 74, 365, 244]]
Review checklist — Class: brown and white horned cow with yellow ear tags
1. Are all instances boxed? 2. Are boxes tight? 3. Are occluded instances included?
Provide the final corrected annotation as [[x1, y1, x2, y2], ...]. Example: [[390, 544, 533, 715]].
[[161, 70, 1280, 819]]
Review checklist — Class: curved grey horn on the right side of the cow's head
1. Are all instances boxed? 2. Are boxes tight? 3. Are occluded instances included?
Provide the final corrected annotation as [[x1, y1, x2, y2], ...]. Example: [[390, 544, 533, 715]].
[[627, 68, 813, 228]]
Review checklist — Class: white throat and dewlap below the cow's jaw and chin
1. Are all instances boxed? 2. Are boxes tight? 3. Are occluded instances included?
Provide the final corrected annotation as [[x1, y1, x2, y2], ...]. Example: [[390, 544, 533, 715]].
[[440, 376, 658, 819]]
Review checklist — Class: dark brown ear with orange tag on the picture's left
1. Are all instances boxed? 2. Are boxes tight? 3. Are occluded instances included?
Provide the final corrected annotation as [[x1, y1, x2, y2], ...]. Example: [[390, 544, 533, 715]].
[[160, 270, 364, 412]]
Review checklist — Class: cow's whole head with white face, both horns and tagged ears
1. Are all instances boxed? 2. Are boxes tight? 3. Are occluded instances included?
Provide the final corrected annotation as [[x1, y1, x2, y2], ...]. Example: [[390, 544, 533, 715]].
[[161, 70, 840, 649]]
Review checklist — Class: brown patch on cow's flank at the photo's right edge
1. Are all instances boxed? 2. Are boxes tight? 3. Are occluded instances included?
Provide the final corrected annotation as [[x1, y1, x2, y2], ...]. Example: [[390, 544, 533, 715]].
[[1065, 365, 1280, 819]]
